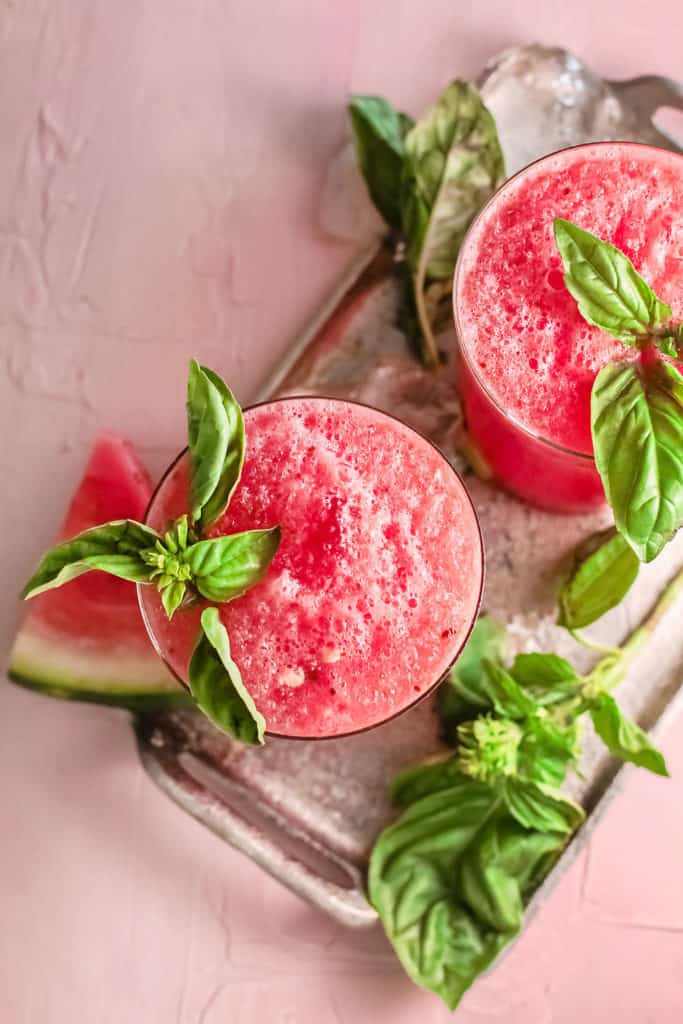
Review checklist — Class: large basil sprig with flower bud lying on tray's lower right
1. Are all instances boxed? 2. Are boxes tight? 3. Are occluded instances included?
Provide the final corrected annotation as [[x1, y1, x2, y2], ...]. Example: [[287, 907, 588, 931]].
[[369, 614, 669, 1010]]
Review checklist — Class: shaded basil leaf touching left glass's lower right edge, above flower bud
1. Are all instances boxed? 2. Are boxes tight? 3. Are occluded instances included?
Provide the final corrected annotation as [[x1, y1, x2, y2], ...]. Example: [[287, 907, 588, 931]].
[[436, 615, 507, 743]]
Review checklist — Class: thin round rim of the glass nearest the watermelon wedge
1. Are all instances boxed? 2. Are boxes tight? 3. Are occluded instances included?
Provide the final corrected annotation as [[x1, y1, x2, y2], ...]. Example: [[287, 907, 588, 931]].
[[135, 393, 486, 742]]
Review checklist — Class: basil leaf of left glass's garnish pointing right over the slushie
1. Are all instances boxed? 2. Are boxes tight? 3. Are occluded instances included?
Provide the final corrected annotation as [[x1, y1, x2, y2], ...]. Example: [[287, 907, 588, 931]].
[[183, 526, 280, 602]]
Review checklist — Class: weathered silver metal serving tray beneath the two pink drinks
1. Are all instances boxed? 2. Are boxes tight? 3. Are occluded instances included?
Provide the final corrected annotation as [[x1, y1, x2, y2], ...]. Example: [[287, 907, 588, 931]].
[[134, 46, 683, 927]]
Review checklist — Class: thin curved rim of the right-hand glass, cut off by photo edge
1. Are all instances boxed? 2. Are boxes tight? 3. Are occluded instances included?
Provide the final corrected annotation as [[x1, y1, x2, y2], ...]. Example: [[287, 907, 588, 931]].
[[452, 139, 683, 465]]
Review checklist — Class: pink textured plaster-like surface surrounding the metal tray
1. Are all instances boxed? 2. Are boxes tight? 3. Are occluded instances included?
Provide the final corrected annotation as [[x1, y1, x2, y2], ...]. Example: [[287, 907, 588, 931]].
[[0, 0, 683, 1024]]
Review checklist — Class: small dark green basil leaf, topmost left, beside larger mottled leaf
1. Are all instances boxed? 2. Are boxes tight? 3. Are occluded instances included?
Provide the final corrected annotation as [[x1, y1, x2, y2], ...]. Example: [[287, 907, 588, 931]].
[[348, 96, 413, 229]]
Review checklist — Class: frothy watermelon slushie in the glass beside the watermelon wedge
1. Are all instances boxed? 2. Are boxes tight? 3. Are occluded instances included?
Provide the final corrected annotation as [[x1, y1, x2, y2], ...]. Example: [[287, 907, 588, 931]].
[[138, 397, 483, 738]]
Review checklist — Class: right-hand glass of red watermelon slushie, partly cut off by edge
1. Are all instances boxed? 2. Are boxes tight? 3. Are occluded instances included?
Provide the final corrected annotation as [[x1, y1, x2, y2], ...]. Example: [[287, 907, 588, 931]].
[[454, 142, 683, 512]]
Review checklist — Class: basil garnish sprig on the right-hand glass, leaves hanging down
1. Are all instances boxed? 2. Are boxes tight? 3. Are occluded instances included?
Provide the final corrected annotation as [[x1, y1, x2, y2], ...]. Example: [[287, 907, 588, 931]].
[[554, 218, 683, 630]]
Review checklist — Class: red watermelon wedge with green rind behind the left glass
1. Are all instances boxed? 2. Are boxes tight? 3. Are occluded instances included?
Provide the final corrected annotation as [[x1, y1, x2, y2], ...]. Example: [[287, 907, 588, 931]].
[[8, 434, 190, 710]]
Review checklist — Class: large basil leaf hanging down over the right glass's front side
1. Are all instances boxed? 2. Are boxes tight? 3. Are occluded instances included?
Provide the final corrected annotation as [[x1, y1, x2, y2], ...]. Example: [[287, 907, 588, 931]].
[[591, 362, 683, 562]]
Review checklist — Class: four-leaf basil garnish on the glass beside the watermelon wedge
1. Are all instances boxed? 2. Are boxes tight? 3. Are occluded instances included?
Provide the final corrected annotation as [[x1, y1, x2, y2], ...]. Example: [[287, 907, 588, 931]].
[[22, 359, 280, 743]]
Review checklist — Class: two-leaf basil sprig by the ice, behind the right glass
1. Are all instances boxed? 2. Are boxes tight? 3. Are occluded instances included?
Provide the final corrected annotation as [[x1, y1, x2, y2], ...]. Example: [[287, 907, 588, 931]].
[[349, 81, 505, 366]]
